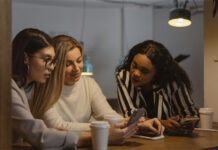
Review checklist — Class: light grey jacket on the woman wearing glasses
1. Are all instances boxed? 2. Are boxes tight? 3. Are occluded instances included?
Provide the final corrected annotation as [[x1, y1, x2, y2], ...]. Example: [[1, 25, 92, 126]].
[[11, 80, 79, 149]]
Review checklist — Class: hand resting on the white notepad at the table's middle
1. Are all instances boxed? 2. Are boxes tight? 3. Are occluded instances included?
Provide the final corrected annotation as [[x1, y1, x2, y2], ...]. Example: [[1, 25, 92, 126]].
[[138, 118, 165, 135]]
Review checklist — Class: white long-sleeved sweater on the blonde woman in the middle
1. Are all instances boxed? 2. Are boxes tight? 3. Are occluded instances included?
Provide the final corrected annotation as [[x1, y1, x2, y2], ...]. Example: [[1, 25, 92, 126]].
[[43, 76, 120, 131]]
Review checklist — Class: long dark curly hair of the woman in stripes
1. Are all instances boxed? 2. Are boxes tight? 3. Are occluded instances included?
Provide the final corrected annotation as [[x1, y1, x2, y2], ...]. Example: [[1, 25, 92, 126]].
[[116, 40, 192, 93]]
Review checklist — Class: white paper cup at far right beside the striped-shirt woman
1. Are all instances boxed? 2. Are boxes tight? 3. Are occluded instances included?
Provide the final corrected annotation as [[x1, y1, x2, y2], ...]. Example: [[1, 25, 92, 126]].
[[199, 108, 214, 129]]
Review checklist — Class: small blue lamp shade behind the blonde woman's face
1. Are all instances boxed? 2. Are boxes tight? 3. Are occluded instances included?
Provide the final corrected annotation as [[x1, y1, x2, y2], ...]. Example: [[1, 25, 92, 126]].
[[82, 55, 93, 76]]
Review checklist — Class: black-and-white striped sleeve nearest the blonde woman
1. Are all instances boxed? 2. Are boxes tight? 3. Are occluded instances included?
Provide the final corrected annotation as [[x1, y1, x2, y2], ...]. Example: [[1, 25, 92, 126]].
[[116, 70, 135, 117]]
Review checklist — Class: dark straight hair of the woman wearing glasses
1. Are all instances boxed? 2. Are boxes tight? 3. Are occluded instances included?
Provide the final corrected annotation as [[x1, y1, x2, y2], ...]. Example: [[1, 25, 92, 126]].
[[12, 28, 52, 87]]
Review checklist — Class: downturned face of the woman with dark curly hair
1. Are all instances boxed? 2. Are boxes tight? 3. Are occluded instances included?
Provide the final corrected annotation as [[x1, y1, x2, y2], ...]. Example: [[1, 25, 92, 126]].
[[130, 54, 156, 87]]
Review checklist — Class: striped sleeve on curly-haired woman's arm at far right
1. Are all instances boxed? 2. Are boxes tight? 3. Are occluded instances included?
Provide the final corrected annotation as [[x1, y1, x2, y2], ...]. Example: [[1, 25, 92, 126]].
[[172, 82, 198, 117]]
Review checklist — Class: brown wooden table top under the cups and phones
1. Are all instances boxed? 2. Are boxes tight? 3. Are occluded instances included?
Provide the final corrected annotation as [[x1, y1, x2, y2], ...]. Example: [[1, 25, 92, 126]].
[[13, 123, 218, 150]]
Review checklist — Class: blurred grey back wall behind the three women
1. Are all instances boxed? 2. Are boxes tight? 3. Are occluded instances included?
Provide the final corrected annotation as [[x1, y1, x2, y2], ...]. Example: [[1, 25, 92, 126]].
[[12, 0, 204, 108]]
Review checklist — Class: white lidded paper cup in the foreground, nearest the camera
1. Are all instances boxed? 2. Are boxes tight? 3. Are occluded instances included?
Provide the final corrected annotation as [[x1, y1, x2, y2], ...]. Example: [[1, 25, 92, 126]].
[[90, 121, 110, 150]]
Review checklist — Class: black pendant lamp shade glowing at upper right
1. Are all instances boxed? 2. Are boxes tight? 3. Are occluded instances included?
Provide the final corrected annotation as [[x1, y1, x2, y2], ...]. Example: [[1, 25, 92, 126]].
[[168, 8, 191, 27]]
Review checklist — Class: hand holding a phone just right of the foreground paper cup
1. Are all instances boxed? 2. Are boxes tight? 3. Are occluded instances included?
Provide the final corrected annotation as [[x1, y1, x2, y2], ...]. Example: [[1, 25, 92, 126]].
[[109, 122, 137, 145]]
